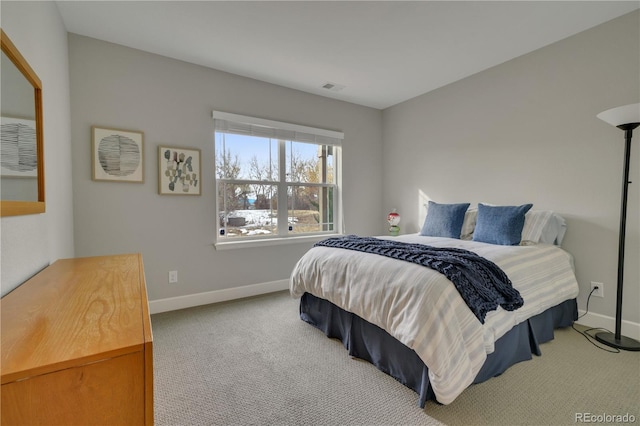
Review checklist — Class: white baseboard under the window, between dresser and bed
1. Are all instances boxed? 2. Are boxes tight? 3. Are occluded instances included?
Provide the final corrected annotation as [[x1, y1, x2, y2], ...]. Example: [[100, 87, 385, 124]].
[[149, 280, 289, 314]]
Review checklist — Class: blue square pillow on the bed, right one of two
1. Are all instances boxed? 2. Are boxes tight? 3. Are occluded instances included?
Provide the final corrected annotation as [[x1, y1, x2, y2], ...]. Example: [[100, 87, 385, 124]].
[[473, 204, 533, 246]]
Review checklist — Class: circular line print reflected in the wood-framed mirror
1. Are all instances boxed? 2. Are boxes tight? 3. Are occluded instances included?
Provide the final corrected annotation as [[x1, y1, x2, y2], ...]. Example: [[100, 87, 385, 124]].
[[0, 117, 38, 178]]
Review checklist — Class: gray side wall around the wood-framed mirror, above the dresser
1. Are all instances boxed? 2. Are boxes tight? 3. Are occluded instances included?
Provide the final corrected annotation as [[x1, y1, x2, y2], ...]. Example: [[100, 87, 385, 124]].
[[0, 1, 74, 295]]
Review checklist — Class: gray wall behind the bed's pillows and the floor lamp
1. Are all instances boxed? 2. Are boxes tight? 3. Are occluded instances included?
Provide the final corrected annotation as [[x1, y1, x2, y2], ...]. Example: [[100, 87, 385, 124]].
[[381, 12, 640, 323]]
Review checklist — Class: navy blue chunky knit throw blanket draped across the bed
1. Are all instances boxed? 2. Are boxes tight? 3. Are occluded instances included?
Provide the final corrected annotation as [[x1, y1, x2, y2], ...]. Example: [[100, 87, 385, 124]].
[[315, 235, 524, 324]]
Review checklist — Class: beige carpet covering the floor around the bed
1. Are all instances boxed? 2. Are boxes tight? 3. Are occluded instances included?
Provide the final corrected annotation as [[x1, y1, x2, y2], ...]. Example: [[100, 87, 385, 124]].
[[152, 292, 640, 425]]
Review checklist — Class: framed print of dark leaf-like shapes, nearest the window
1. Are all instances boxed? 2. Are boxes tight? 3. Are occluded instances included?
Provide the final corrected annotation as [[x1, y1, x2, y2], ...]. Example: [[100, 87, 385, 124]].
[[158, 146, 202, 195]]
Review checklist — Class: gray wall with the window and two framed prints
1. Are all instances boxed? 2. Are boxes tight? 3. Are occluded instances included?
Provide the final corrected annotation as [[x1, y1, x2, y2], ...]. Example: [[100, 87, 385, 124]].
[[69, 34, 384, 300]]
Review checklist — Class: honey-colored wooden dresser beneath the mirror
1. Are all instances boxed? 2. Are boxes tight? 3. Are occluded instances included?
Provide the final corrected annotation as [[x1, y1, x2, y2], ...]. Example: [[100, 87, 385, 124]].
[[0, 254, 153, 426]]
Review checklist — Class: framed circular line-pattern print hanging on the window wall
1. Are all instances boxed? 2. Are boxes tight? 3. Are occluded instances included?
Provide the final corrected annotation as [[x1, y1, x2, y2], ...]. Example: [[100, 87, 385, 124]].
[[91, 126, 144, 183]]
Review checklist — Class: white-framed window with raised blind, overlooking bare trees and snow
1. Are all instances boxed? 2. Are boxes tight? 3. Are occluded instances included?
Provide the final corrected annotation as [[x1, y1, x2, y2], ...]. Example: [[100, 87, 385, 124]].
[[213, 111, 343, 243]]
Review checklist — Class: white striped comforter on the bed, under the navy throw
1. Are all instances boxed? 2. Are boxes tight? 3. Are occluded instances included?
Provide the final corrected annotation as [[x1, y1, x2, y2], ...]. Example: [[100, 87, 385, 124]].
[[290, 234, 578, 404]]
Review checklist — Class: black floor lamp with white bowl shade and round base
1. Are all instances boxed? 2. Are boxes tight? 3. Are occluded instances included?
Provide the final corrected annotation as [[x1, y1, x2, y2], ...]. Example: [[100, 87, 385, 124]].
[[596, 104, 640, 351]]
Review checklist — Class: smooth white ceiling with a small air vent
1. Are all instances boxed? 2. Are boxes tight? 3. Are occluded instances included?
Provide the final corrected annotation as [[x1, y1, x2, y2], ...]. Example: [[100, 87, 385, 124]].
[[57, 0, 640, 109]]
